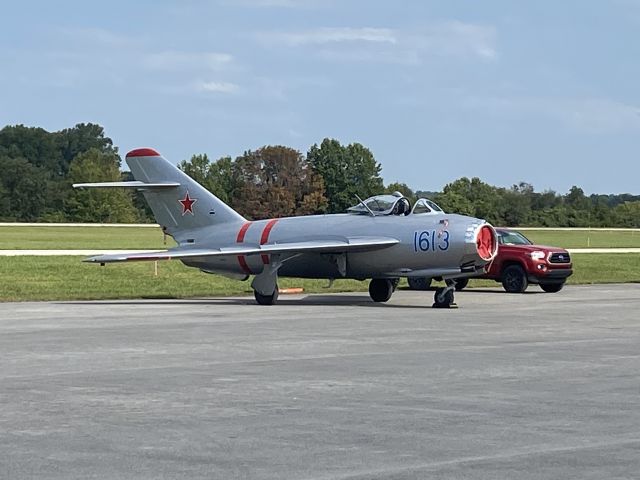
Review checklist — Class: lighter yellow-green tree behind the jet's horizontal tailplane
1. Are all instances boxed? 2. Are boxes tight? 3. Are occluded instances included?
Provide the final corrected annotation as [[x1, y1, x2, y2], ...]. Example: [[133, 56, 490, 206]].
[[65, 148, 138, 223]]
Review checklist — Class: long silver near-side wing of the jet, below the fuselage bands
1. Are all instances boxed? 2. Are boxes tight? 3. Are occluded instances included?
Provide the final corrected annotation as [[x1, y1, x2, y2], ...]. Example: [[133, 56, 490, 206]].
[[84, 237, 399, 263]]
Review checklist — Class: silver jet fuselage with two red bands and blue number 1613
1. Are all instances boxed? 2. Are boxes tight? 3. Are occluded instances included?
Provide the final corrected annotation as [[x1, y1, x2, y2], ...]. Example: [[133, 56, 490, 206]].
[[182, 214, 491, 279]]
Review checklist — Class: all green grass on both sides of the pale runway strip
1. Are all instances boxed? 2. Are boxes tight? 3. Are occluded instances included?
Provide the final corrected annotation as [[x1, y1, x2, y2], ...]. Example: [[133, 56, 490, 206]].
[[0, 226, 640, 301]]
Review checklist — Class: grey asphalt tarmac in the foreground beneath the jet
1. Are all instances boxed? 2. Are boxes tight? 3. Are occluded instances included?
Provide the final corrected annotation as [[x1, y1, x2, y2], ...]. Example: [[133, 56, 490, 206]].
[[0, 285, 640, 480]]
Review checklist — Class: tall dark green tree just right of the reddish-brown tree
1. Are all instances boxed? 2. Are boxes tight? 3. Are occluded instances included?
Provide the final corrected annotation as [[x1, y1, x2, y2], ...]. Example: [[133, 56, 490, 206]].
[[307, 138, 384, 213]]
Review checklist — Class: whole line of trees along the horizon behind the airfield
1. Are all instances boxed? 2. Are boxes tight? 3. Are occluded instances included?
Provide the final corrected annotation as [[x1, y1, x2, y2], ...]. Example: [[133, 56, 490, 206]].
[[0, 123, 640, 228]]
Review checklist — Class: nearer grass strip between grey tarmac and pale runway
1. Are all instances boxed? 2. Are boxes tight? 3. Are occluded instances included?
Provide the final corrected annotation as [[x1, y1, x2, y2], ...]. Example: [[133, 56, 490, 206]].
[[0, 254, 640, 301]]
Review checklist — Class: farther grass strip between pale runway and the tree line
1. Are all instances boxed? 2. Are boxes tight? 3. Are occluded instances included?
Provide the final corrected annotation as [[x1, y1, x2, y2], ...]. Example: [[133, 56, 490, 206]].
[[0, 226, 640, 250]]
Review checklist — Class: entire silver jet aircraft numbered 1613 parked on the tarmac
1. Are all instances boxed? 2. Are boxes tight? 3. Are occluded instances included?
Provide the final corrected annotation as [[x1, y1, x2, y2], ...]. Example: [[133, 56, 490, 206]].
[[73, 148, 498, 308]]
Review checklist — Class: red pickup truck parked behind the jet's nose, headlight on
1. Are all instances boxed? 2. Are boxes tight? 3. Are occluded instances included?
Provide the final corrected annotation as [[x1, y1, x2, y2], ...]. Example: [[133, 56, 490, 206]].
[[408, 228, 573, 293]]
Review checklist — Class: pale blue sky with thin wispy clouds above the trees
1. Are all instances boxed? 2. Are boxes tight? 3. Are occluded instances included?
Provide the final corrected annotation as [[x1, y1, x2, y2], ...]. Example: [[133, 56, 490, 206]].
[[0, 0, 640, 194]]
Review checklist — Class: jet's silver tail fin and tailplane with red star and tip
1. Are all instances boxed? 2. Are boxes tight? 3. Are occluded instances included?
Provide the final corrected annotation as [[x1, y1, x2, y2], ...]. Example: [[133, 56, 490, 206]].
[[74, 148, 246, 243]]
